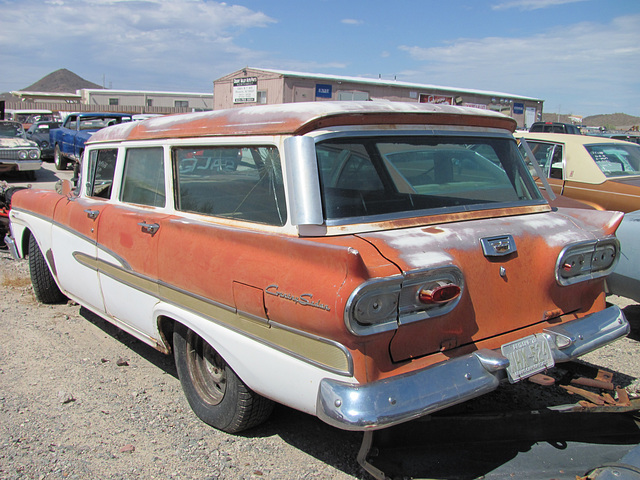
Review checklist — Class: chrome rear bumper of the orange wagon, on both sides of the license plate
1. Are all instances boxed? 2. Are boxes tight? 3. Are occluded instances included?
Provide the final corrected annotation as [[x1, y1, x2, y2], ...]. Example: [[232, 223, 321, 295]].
[[316, 306, 629, 430]]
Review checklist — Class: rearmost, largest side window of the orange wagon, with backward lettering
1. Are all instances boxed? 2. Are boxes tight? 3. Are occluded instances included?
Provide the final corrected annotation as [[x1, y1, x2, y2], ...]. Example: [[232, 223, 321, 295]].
[[173, 146, 287, 226]]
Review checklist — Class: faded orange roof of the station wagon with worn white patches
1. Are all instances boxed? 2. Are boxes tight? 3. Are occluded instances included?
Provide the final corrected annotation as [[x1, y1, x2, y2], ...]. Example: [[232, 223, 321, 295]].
[[88, 101, 516, 143]]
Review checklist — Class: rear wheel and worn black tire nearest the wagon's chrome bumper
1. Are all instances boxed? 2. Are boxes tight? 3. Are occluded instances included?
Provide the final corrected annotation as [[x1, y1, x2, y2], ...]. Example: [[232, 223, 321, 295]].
[[173, 324, 273, 433]]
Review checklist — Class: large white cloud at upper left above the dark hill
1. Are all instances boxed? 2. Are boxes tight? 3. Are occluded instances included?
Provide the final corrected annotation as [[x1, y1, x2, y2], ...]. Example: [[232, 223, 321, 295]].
[[0, 0, 276, 91]]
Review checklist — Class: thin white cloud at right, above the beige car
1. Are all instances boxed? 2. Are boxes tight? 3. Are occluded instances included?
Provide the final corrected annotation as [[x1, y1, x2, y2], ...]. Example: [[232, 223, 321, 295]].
[[399, 15, 640, 113]]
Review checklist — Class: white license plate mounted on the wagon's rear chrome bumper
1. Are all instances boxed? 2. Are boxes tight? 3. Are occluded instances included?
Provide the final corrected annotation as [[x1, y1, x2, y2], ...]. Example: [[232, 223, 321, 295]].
[[501, 335, 554, 383]]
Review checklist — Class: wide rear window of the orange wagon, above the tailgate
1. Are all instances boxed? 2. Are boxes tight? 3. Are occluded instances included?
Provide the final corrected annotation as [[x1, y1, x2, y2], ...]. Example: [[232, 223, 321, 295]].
[[316, 136, 542, 220]]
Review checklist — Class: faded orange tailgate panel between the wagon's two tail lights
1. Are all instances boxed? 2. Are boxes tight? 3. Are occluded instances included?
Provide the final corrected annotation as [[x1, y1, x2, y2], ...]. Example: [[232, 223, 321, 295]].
[[359, 210, 614, 361]]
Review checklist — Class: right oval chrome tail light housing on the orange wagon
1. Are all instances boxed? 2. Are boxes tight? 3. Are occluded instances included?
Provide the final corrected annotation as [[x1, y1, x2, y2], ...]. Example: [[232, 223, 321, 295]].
[[556, 237, 620, 286]]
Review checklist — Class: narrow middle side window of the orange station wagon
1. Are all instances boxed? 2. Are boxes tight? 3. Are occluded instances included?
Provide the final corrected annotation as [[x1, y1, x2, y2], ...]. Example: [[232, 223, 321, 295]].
[[120, 147, 166, 207]]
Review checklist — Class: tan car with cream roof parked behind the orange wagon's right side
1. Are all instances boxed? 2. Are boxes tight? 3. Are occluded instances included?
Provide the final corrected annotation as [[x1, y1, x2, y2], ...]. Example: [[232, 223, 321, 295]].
[[514, 132, 640, 213]]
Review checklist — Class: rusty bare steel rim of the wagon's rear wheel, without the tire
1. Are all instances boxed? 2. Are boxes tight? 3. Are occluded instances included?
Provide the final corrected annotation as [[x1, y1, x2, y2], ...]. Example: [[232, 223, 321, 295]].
[[187, 330, 227, 405]]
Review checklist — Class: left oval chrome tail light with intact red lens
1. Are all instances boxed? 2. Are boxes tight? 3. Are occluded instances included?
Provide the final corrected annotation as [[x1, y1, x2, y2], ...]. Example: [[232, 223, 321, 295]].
[[344, 266, 464, 335]]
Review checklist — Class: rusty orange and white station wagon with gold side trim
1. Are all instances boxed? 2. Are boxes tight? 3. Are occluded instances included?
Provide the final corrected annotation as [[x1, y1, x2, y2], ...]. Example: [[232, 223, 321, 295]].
[[7, 102, 629, 432]]
